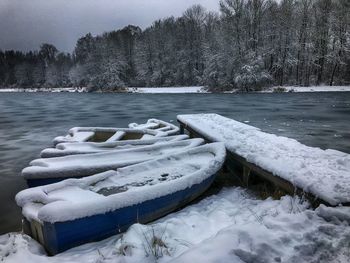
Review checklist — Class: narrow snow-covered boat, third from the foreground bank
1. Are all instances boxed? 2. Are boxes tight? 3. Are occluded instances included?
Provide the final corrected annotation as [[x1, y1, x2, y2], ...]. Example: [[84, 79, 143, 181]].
[[40, 134, 188, 158]]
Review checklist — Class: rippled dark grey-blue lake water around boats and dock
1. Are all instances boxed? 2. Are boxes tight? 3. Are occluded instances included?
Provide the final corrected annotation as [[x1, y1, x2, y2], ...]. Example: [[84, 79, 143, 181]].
[[0, 92, 350, 234]]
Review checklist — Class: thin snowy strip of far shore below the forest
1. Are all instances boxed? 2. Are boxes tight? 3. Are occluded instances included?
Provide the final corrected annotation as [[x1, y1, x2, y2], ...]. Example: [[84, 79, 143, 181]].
[[0, 86, 350, 94]]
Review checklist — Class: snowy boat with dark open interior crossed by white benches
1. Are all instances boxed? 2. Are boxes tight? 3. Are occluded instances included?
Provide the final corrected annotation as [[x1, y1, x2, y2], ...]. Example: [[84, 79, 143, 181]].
[[53, 127, 168, 145]]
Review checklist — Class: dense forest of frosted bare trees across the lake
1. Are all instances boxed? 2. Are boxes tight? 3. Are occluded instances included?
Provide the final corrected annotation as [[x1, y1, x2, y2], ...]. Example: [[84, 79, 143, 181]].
[[0, 0, 350, 91]]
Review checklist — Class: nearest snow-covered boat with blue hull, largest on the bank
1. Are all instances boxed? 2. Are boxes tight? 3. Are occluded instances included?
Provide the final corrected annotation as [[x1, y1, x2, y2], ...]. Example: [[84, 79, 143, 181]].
[[16, 143, 226, 255]]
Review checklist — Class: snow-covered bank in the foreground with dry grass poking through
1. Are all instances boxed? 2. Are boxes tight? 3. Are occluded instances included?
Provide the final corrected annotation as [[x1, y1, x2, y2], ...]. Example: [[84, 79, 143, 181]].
[[0, 188, 350, 263]]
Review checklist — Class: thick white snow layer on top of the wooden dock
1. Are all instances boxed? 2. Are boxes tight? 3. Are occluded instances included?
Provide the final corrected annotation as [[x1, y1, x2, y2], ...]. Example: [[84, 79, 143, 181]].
[[178, 114, 350, 205]]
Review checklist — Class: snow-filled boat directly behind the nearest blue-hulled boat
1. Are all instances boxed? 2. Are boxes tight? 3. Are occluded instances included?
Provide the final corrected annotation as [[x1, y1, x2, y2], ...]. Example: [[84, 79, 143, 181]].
[[22, 139, 204, 187]]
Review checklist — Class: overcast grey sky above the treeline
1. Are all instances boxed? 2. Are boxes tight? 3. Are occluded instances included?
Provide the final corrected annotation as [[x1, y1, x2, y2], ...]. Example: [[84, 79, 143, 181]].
[[0, 0, 219, 52]]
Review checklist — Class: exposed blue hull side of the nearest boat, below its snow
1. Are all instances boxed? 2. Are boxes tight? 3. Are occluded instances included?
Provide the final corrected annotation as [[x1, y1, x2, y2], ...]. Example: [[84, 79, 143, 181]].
[[25, 175, 215, 255]]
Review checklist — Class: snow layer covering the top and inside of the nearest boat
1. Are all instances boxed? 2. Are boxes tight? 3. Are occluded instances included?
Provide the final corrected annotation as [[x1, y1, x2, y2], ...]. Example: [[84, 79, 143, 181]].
[[16, 143, 226, 223]]
